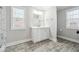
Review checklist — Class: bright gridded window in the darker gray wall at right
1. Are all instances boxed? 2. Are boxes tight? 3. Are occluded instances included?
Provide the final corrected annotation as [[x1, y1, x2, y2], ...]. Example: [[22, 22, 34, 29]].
[[66, 8, 79, 29]]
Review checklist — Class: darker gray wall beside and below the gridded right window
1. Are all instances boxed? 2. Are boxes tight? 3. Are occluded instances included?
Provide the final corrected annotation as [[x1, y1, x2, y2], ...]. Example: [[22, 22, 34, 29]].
[[57, 8, 79, 40]]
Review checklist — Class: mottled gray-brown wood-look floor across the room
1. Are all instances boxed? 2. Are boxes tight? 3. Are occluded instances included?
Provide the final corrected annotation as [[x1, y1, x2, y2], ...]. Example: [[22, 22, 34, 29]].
[[5, 38, 79, 52]]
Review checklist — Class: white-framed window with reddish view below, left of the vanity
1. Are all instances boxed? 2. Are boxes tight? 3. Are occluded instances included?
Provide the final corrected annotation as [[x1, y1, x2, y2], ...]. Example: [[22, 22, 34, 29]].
[[11, 7, 25, 29]]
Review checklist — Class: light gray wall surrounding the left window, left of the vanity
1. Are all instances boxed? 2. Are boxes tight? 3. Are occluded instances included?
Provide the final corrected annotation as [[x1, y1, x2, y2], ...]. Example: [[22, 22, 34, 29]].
[[6, 6, 30, 43]]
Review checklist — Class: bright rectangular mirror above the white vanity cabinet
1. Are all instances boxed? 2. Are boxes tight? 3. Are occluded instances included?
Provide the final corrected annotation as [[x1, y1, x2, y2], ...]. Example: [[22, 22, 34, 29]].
[[32, 9, 44, 26]]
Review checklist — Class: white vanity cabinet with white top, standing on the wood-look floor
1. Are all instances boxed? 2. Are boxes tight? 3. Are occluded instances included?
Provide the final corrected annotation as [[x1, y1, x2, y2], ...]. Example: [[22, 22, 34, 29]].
[[32, 27, 49, 42]]
